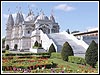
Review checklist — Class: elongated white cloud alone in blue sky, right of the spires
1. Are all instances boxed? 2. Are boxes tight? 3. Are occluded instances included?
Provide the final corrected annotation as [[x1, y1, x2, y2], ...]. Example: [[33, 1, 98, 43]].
[[54, 4, 75, 11]]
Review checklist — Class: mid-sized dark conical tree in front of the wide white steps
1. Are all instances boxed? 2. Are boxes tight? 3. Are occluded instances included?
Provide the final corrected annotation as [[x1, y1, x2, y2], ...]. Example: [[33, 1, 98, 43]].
[[61, 42, 74, 61]]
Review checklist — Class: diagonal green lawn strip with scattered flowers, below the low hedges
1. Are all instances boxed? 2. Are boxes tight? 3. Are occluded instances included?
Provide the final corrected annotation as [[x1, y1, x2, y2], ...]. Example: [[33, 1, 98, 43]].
[[49, 58, 98, 73]]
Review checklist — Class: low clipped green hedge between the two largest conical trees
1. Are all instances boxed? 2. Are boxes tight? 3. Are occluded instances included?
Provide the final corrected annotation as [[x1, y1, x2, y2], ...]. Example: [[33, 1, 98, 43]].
[[68, 56, 86, 65]]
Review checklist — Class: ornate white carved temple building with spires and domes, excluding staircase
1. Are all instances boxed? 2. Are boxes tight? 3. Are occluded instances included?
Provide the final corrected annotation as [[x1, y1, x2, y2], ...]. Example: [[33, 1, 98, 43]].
[[5, 11, 59, 49]]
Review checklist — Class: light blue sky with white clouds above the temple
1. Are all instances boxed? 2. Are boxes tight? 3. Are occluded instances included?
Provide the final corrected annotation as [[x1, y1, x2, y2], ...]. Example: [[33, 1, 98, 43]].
[[1, 1, 99, 37]]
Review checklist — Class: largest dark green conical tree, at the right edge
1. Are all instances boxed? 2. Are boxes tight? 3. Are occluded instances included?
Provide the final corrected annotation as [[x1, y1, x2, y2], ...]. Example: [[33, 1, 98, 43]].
[[85, 40, 98, 67]]
